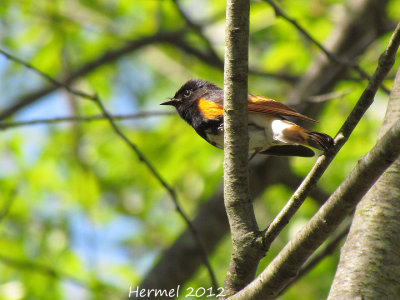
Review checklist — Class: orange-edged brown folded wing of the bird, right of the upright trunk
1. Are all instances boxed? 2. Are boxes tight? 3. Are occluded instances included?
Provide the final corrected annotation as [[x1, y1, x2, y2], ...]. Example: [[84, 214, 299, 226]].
[[248, 94, 317, 122]]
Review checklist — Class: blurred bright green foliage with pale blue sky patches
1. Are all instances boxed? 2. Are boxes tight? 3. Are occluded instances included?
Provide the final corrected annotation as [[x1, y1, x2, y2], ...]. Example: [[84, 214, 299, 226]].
[[0, 0, 400, 300]]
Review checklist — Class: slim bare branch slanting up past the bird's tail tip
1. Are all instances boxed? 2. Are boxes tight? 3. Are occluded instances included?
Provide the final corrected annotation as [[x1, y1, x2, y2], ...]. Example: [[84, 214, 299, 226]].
[[262, 23, 400, 250]]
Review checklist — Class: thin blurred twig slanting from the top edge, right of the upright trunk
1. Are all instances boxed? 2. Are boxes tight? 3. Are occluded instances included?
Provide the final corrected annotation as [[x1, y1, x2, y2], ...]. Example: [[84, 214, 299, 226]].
[[264, 0, 390, 94]]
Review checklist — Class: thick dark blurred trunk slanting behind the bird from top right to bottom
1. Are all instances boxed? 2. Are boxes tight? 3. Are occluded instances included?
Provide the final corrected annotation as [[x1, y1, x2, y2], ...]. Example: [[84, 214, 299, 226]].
[[134, 0, 387, 296]]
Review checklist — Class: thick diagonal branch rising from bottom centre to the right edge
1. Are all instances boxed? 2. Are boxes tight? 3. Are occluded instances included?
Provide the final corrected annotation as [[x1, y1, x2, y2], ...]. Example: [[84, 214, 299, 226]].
[[230, 121, 400, 300]]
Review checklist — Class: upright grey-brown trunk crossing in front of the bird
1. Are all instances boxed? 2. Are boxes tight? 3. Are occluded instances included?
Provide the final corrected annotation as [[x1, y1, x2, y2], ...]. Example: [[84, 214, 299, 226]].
[[224, 0, 263, 295]]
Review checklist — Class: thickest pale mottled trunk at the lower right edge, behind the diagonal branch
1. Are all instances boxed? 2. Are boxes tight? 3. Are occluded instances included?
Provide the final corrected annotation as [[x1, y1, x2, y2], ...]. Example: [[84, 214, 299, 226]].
[[329, 70, 400, 299]]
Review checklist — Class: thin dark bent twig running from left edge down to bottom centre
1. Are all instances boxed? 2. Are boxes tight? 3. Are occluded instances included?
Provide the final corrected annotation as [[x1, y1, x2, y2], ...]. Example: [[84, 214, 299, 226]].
[[0, 50, 218, 290]]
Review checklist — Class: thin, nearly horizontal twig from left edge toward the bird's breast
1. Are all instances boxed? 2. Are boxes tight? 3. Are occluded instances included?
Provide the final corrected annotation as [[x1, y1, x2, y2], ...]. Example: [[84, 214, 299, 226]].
[[0, 111, 172, 130]]
